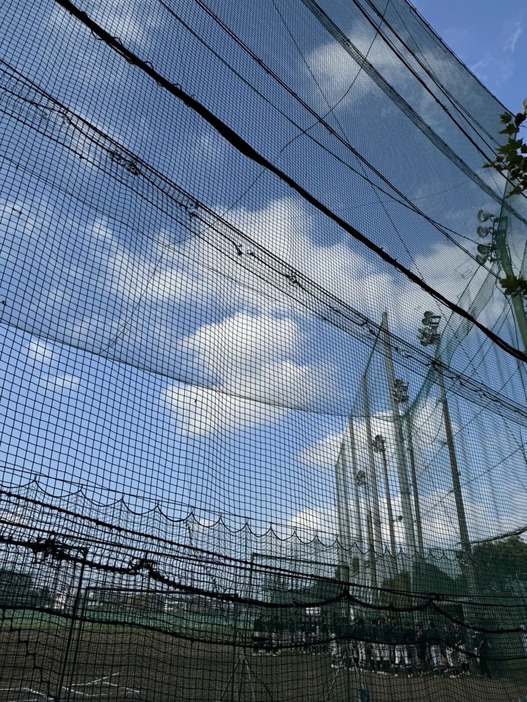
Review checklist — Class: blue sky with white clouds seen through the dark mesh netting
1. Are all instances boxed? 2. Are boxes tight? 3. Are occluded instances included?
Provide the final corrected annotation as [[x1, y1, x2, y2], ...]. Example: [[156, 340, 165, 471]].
[[0, 0, 524, 560]]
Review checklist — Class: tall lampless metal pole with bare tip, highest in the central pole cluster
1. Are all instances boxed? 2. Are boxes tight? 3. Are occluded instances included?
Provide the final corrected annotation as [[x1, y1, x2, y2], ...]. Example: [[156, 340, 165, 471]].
[[381, 312, 416, 555]]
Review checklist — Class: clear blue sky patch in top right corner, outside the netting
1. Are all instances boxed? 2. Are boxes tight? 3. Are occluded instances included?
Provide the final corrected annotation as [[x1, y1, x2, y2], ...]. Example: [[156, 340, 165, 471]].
[[412, 0, 527, 112]]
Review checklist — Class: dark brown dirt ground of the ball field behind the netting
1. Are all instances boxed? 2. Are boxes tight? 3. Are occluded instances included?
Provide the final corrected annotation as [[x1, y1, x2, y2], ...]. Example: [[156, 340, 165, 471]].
[[0, 630, 527, 702]]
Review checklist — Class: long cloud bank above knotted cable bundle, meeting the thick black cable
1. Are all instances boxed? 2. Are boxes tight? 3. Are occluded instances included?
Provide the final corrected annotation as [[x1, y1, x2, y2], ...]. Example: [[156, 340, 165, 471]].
[[230, 198, 501, 338]]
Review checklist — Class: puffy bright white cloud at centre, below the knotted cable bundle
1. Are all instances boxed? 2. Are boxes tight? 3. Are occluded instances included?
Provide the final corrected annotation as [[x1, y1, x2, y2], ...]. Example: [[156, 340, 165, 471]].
[[164, 312, 334, 433]]
